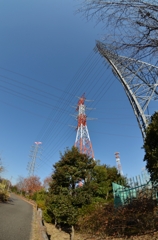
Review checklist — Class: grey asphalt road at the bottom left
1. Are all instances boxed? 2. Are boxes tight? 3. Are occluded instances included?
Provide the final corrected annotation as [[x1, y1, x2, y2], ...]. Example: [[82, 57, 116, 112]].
[[0, 194, 33, 240]]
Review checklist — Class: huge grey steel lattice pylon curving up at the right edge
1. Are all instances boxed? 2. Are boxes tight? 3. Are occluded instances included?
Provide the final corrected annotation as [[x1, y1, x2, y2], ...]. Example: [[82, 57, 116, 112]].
[[96, 41, 158, 140]]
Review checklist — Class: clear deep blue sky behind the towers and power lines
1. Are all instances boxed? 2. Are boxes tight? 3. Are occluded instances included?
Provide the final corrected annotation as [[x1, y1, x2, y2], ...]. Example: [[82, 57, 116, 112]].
[[0, 0, 156, 184]]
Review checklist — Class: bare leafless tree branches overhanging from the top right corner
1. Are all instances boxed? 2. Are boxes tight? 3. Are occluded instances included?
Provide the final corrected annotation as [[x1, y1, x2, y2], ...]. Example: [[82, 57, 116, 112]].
[[78, 0, 158, 59]]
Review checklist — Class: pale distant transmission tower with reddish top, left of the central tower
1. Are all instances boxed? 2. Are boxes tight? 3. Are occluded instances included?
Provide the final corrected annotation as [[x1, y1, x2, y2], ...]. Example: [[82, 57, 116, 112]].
[[27, 142, 42, 176]]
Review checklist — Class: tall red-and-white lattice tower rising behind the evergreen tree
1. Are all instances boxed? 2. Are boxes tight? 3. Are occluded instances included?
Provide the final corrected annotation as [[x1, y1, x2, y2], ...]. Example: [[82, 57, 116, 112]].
[[75, 94, 94, 159]]
